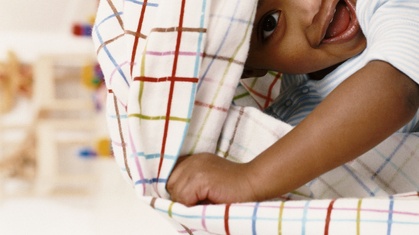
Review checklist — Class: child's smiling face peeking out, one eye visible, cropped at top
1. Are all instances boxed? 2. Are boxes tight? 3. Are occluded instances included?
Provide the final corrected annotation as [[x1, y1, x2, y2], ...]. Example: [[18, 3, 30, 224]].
[[246, 0, 366, 73]]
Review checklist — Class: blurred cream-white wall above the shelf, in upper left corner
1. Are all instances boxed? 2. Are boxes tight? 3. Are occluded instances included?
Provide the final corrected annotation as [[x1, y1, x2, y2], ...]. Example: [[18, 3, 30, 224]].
[[0, 0, 97, 62]]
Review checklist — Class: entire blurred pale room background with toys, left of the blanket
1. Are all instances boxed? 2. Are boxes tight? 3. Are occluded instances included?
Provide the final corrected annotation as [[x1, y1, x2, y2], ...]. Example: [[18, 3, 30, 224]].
[[0, 0, 174, 235]]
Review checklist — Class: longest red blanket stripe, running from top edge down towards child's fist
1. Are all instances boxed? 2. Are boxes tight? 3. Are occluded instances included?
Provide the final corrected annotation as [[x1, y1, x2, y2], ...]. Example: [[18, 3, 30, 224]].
[[157, 0, 186, 179]]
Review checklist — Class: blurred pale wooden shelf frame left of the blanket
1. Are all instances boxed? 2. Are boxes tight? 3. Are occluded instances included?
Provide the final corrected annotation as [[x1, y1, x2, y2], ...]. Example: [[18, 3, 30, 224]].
[[33, 55, 98, 194]]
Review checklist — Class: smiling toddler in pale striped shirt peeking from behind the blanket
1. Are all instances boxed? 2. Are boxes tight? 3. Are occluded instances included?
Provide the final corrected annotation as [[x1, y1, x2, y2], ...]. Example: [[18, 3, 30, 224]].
[[167, 0, 419, 205]]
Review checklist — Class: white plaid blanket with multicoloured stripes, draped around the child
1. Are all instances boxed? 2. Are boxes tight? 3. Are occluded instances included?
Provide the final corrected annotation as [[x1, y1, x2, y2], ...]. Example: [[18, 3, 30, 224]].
[[92, 0, 419, 234]]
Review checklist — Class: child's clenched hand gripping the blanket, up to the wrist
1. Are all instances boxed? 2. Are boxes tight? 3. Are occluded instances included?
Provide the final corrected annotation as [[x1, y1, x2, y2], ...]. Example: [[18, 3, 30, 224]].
[[167, 153, 255, 206]]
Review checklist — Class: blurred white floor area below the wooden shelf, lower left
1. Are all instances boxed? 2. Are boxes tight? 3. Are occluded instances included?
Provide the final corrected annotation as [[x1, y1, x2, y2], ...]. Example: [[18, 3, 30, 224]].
[[0, 160, 178, 235]]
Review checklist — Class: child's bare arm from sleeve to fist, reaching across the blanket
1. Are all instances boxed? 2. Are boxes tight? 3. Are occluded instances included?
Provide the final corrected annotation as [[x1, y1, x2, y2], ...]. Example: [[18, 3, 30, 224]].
[[168, 61, 419, 205]]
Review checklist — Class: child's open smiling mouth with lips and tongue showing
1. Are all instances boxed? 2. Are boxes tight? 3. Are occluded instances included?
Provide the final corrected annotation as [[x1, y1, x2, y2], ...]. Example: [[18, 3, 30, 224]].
[[321, 0, 359, 43]]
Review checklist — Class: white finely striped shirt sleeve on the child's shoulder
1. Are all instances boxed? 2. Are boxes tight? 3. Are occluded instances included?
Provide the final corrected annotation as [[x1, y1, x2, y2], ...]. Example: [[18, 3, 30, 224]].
[[357, 0, 419, 83]]
